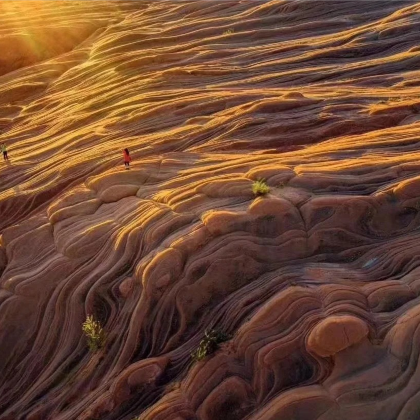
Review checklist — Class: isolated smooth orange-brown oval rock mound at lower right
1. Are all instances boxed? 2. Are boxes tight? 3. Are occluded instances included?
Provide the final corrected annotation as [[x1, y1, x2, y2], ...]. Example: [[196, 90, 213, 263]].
[[307, 315, 369, 357]]
